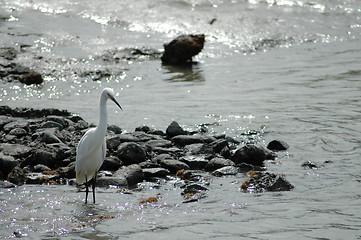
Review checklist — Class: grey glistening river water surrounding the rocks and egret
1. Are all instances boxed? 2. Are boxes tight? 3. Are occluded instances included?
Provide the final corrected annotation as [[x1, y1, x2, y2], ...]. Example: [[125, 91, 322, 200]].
[[0, 0, 361, 239]]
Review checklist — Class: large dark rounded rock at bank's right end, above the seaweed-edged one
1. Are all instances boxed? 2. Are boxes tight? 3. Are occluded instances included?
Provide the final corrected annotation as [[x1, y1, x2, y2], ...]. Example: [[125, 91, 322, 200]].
[[231, 144, 275, 166]]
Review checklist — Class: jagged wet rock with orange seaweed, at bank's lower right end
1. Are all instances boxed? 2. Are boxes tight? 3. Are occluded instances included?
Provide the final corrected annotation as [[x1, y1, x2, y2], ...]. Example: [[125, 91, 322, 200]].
[[241, 171, 294, 193]]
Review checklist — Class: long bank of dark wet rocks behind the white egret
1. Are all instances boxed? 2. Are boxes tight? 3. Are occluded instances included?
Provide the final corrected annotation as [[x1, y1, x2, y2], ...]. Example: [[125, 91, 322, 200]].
[[0, 106, 293, 201]]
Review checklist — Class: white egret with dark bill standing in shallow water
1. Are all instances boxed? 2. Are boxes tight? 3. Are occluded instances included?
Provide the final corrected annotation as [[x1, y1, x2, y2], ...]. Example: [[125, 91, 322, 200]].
[[75, 88, 122, 203]]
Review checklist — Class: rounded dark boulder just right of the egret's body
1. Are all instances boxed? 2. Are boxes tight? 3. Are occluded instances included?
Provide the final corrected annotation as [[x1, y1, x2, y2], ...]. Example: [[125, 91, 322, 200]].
[[117, 142, 147, 165]]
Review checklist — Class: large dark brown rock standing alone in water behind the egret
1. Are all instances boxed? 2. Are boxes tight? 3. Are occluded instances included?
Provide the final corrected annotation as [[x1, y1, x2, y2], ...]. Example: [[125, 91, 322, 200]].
[[161, 34, 205, 65]]
